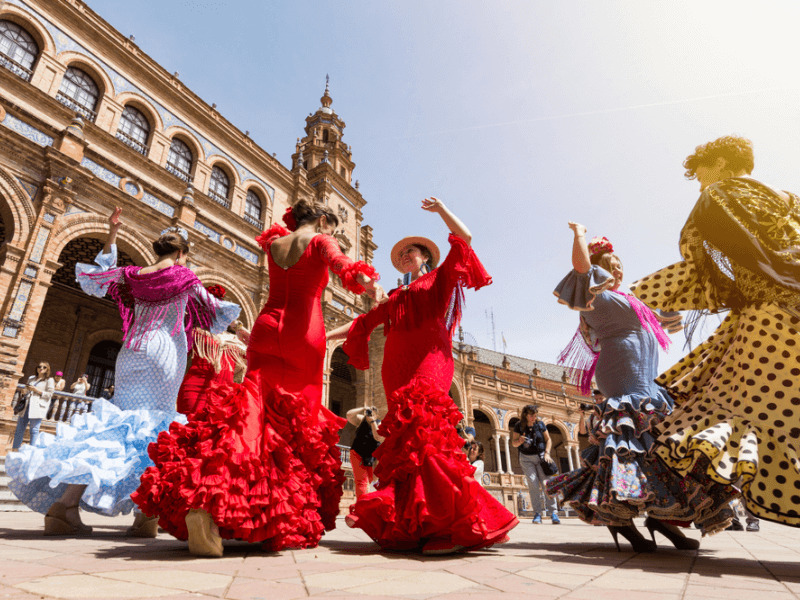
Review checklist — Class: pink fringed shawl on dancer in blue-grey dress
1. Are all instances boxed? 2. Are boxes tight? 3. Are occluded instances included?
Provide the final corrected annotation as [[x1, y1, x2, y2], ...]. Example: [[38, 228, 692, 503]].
[[558, 290, 671, 395]]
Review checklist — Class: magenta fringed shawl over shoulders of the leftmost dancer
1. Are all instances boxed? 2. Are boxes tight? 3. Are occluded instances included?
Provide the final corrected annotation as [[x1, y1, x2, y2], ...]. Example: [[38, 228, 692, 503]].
[[80, 265, 219, 350]]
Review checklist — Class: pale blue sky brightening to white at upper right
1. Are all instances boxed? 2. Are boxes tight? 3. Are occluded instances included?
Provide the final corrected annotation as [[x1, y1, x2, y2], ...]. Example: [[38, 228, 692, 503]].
[[88, 0, 800, 369]]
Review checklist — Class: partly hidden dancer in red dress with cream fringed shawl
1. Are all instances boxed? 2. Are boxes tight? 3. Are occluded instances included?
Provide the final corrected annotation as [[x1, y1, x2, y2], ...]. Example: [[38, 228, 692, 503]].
[[177, 284, 250, 420]]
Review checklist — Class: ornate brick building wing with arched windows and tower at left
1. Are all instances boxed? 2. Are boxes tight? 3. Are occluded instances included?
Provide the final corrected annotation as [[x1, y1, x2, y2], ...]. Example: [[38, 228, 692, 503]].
[[0, 0, 375, 454]]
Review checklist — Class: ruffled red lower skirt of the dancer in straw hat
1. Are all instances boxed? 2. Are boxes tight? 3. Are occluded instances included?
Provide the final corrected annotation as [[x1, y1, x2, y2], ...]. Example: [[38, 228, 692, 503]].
[[349, 379, 518, 550]]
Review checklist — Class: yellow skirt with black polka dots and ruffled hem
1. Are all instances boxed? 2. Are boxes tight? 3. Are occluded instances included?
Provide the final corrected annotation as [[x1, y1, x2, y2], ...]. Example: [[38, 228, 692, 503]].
[[656, 304, 800, 527]]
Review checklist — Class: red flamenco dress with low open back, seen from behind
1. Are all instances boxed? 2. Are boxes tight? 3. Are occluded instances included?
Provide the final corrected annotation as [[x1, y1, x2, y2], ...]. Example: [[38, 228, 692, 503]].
[[132, 225, 376, 551]]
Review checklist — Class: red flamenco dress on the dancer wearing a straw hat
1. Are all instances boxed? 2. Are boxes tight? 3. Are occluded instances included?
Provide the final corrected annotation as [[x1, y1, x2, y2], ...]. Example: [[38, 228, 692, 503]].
[[344, 234, 518, 552]]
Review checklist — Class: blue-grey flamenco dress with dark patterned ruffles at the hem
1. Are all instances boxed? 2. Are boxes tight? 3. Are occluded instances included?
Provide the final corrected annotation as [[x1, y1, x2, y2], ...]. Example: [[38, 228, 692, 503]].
[[547, 266, 733, 529]]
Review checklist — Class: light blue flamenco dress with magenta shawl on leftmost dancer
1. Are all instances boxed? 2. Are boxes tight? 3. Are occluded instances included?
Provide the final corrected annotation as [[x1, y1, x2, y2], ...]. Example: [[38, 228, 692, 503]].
[[6, 246, 241, 516]]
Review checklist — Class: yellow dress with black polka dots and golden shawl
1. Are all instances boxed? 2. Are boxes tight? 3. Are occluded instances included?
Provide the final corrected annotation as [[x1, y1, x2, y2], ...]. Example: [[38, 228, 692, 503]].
[[633, 178, 800, 527]]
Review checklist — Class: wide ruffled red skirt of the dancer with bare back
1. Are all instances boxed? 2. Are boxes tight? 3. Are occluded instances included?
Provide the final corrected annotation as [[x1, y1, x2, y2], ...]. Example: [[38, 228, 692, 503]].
[[131, 371, 344, 551]]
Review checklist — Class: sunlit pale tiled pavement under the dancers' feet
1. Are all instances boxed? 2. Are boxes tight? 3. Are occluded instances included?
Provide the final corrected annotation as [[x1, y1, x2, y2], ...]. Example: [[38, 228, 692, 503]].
[[0, 513, 800, 600]]
